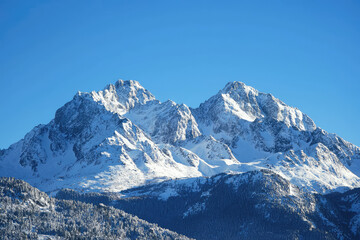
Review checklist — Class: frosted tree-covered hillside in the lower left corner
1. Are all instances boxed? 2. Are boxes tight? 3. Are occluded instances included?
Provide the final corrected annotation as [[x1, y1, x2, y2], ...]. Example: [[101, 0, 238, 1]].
[[0, 178, 188, 239]]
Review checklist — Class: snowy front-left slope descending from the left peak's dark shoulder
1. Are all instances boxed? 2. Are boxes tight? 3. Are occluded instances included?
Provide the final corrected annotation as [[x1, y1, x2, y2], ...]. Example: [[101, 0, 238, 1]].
[[0, 82, 201, 191]]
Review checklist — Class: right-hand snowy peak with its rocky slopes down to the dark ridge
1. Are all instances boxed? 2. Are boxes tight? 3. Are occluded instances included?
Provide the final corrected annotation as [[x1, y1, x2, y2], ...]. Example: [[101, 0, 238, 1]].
[[192, 82, 360, 192]]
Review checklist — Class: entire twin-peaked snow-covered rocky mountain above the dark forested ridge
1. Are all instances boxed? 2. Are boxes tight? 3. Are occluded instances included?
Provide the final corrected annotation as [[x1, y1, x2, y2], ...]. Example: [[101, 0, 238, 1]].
[[0, 80, 360, 192]]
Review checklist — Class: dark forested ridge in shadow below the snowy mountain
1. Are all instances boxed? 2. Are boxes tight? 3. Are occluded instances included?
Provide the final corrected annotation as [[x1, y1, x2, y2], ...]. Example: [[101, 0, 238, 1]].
[[56, 169, 360, 240]]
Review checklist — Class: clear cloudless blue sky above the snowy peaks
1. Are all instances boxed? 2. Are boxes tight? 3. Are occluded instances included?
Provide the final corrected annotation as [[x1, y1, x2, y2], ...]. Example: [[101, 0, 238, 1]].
[[0, 0, 360, 148]]
